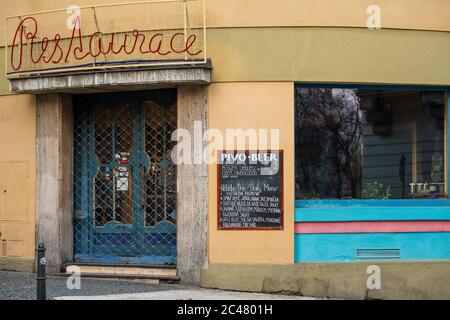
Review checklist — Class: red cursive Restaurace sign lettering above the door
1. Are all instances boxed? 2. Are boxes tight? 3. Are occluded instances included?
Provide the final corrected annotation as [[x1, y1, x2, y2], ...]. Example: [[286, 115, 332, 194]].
[[10, 17, 202, 71]]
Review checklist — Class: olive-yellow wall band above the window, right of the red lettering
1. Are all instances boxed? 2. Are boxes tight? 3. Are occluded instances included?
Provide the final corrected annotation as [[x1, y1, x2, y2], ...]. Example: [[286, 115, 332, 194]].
[[0, 26, 450, 95]]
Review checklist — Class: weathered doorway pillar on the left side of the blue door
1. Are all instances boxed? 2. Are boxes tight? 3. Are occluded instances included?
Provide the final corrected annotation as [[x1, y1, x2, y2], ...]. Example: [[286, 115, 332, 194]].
[[36, 94, 73, 274]]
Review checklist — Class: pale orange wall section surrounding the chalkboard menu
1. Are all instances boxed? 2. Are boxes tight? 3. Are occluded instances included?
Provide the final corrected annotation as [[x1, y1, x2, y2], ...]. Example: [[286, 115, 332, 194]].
[[208, 82, 294, 264]]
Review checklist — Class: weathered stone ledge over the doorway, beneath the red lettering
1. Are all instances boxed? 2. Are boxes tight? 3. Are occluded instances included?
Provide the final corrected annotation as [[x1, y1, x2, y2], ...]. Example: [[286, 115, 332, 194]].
[[10, 64, 211, 94]]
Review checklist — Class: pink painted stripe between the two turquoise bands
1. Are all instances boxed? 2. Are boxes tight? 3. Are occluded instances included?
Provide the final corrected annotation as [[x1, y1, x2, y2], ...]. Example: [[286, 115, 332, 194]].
[[295, 221, 450, 234]]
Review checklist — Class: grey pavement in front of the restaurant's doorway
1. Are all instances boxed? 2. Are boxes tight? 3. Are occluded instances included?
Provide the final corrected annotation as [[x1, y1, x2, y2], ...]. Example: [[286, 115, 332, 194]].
[[0, 271, 324, 300]]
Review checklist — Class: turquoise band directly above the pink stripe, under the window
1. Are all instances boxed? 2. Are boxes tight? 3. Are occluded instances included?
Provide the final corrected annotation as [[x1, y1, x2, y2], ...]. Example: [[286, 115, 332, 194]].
[[295, 206, 450, 222]]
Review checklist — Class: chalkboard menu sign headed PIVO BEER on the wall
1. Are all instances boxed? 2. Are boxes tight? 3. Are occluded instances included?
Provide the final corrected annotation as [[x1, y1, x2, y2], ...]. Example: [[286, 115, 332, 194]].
[[217, 151, 283, 230]]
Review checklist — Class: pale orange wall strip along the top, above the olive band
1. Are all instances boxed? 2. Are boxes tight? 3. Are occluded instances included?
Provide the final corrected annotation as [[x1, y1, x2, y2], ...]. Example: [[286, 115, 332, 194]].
[[0, 0, 450, 45]]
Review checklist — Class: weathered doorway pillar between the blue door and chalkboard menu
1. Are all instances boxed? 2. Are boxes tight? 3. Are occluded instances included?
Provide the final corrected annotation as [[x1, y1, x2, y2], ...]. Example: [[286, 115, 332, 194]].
[[177, 85, 208, 284]]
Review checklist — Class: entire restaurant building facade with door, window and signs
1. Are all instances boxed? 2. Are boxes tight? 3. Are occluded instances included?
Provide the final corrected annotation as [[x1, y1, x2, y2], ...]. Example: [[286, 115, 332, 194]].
[[0, 0, 450, 298]]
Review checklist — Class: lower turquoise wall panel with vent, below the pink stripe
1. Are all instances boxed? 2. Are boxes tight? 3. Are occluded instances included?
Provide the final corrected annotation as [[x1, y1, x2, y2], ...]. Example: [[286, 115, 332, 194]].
[[295, 233, 450, 263]]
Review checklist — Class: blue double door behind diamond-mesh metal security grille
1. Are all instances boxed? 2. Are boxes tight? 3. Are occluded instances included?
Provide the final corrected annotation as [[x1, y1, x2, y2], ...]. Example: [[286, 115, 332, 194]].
[[74, 90, 177, 264]]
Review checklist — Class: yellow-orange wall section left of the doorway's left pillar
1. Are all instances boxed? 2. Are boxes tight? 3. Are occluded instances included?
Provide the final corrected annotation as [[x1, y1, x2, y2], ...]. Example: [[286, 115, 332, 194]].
[[0, 95, 36, 269]]
